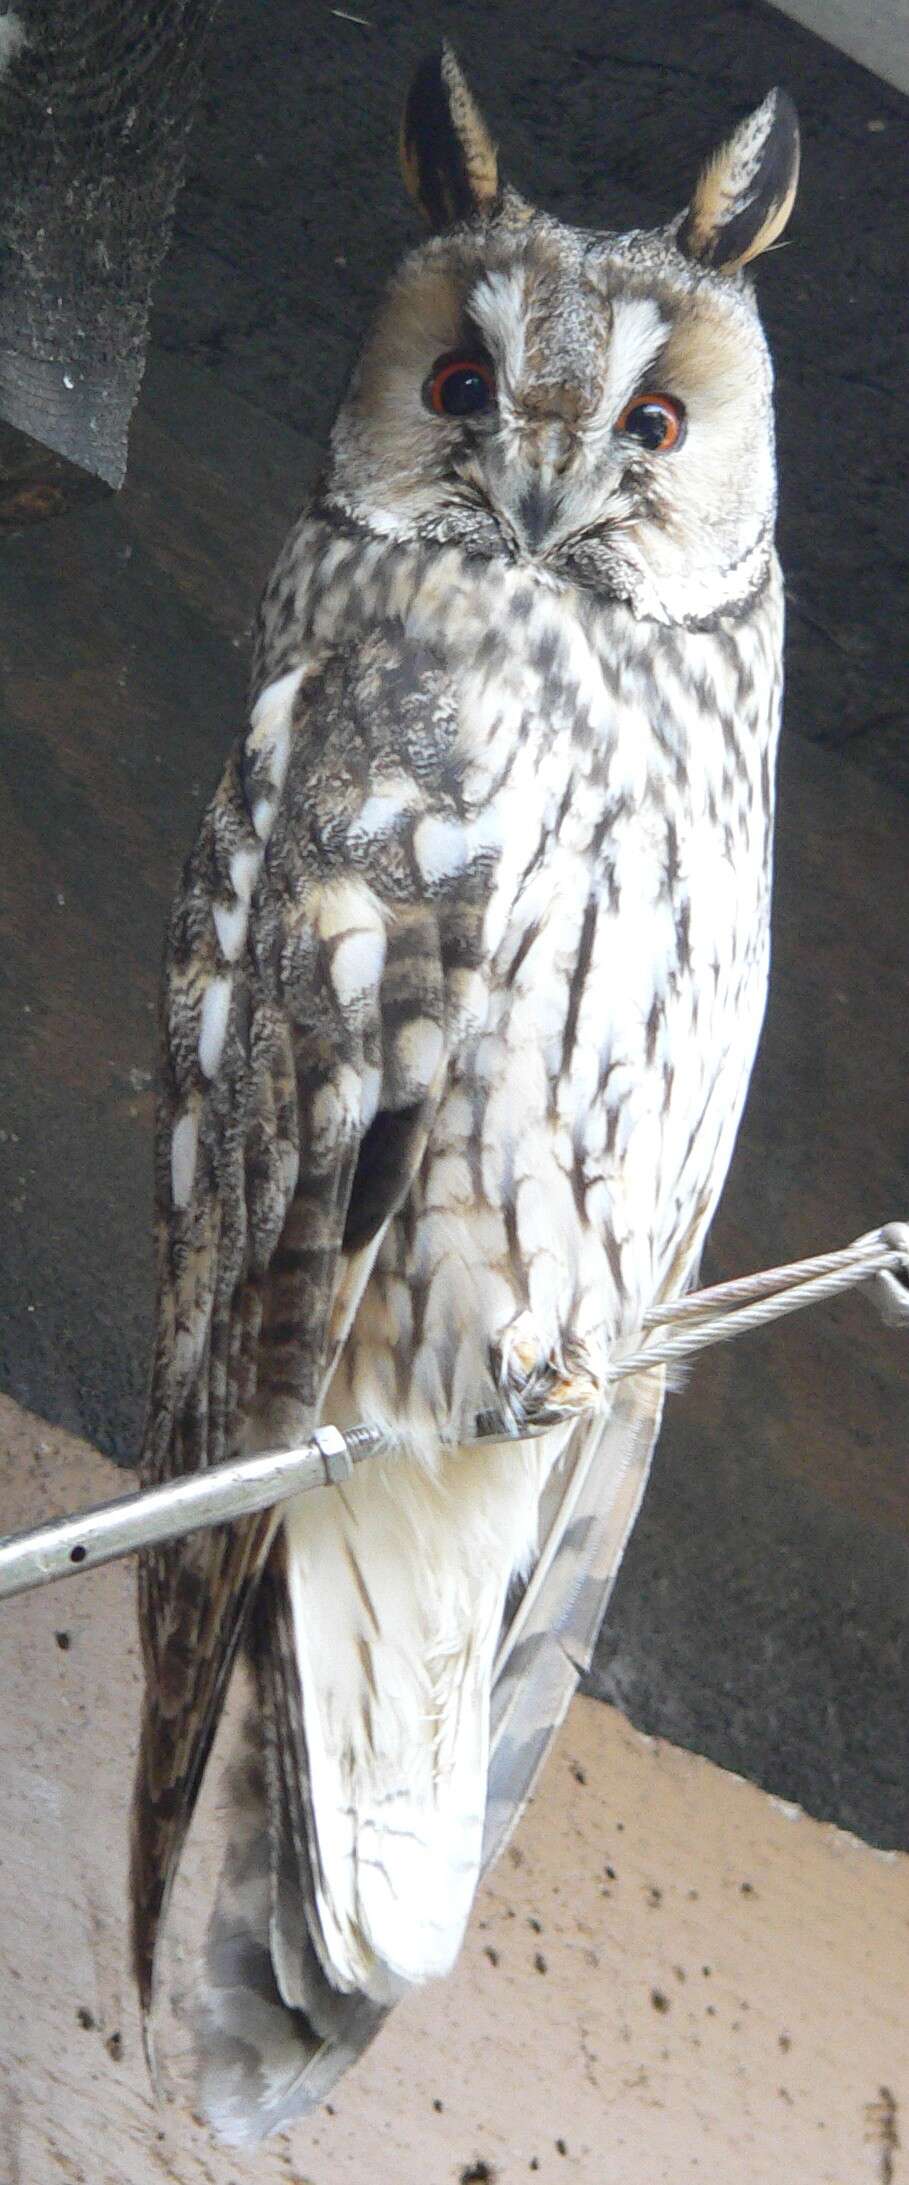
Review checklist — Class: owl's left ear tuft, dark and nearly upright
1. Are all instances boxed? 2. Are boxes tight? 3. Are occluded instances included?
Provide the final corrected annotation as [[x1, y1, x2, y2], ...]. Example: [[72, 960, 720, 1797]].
[[400, 44, 498, 229]]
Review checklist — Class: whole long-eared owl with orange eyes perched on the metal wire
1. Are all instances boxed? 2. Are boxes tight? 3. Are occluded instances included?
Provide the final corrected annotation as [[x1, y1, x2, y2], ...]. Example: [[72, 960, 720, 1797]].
[[133, 48, 798, 2139]]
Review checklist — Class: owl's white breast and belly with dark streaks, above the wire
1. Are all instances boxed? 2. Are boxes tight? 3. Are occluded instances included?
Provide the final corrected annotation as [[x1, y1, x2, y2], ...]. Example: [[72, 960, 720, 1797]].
[[327, 572, 778, 1431]]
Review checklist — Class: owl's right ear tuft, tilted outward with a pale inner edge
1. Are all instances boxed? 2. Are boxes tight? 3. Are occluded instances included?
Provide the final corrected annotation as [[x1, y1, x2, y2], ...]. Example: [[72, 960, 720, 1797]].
[[675, 92, 800, 273]]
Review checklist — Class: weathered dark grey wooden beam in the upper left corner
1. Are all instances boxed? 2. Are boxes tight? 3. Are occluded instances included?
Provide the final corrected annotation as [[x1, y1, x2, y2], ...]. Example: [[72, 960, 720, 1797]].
[[0, 0, 216, 482]]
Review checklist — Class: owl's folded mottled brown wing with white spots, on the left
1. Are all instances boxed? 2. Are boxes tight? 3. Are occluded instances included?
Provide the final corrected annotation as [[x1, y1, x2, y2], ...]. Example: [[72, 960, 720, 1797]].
[[133, 634, 485, 2001]]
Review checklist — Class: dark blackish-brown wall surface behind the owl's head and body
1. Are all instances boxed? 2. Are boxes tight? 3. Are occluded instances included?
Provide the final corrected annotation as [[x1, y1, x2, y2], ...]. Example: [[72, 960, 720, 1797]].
[[0, 0, 909, 1846]]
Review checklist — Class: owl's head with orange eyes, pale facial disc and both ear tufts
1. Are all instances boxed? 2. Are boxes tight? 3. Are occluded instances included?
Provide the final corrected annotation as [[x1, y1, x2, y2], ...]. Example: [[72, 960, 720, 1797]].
[[328, 46, 798, 621]]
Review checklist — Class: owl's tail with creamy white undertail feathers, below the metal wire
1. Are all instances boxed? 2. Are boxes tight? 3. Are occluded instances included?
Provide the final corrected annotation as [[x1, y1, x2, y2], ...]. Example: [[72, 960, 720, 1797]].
[[147, 1374, 662, 2143]]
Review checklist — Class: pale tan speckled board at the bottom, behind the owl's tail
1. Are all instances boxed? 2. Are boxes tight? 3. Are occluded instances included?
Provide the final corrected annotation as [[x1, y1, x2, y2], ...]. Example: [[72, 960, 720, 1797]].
[[0, 1398, 909, 2185]]
